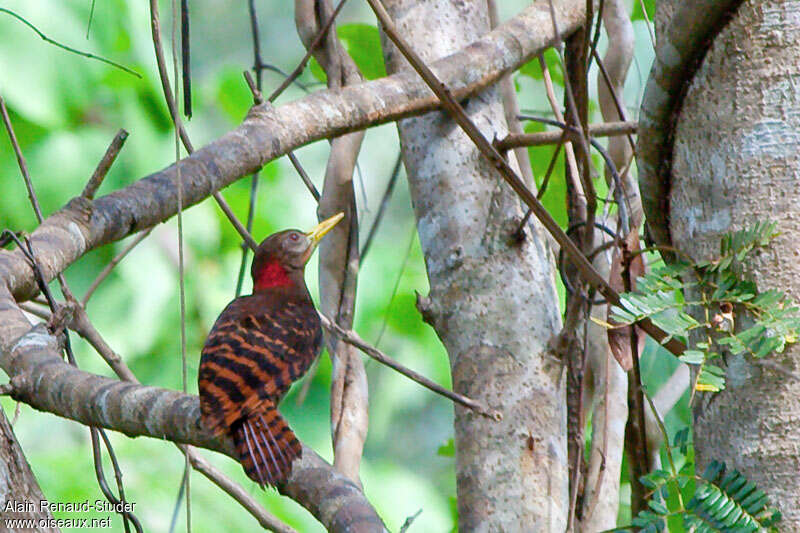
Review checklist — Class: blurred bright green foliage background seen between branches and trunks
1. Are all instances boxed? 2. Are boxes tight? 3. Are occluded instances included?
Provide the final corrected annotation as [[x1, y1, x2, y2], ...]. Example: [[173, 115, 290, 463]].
[[0, 0, 688, 532]]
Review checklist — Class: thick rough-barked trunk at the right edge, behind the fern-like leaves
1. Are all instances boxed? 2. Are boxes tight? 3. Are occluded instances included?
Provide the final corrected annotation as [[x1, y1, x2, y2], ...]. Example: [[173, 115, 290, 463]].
[[648, 0, 800, 531]]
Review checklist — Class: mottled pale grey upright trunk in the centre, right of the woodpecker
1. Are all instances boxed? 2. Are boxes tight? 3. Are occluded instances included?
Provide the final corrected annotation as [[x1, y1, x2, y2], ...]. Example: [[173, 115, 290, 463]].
[[384, 0, 568, 531]]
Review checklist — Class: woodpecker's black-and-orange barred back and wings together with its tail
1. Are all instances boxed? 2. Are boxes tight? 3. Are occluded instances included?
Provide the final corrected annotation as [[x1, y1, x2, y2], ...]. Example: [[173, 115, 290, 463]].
[[198, 294, 322, 485]]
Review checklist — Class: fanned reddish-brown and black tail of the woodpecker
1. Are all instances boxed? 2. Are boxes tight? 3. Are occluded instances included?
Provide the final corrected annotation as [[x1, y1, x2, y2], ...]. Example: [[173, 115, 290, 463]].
[[236, 401, 302, 487]]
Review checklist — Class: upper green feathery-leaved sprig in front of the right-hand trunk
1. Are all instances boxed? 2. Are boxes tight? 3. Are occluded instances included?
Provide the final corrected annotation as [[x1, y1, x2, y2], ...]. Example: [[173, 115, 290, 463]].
[[611, 222, 800, 392]]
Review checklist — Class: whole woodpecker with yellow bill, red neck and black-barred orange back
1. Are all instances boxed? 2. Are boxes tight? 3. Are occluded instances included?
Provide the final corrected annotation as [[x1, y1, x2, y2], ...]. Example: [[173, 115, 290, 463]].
[[197, 213, 344, 488]]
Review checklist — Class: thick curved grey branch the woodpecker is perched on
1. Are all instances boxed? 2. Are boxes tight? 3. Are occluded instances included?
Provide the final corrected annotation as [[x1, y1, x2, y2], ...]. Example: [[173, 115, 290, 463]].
[[0, 306, 384, 532]]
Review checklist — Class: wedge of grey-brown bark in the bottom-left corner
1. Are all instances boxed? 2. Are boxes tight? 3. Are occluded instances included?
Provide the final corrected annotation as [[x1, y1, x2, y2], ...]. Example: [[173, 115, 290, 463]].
[[0, 409, 59, 532]]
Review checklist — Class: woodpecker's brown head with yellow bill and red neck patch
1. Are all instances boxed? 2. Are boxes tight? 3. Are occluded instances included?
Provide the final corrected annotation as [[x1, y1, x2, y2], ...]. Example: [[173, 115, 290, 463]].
[[250, 213, 344, 290]]
